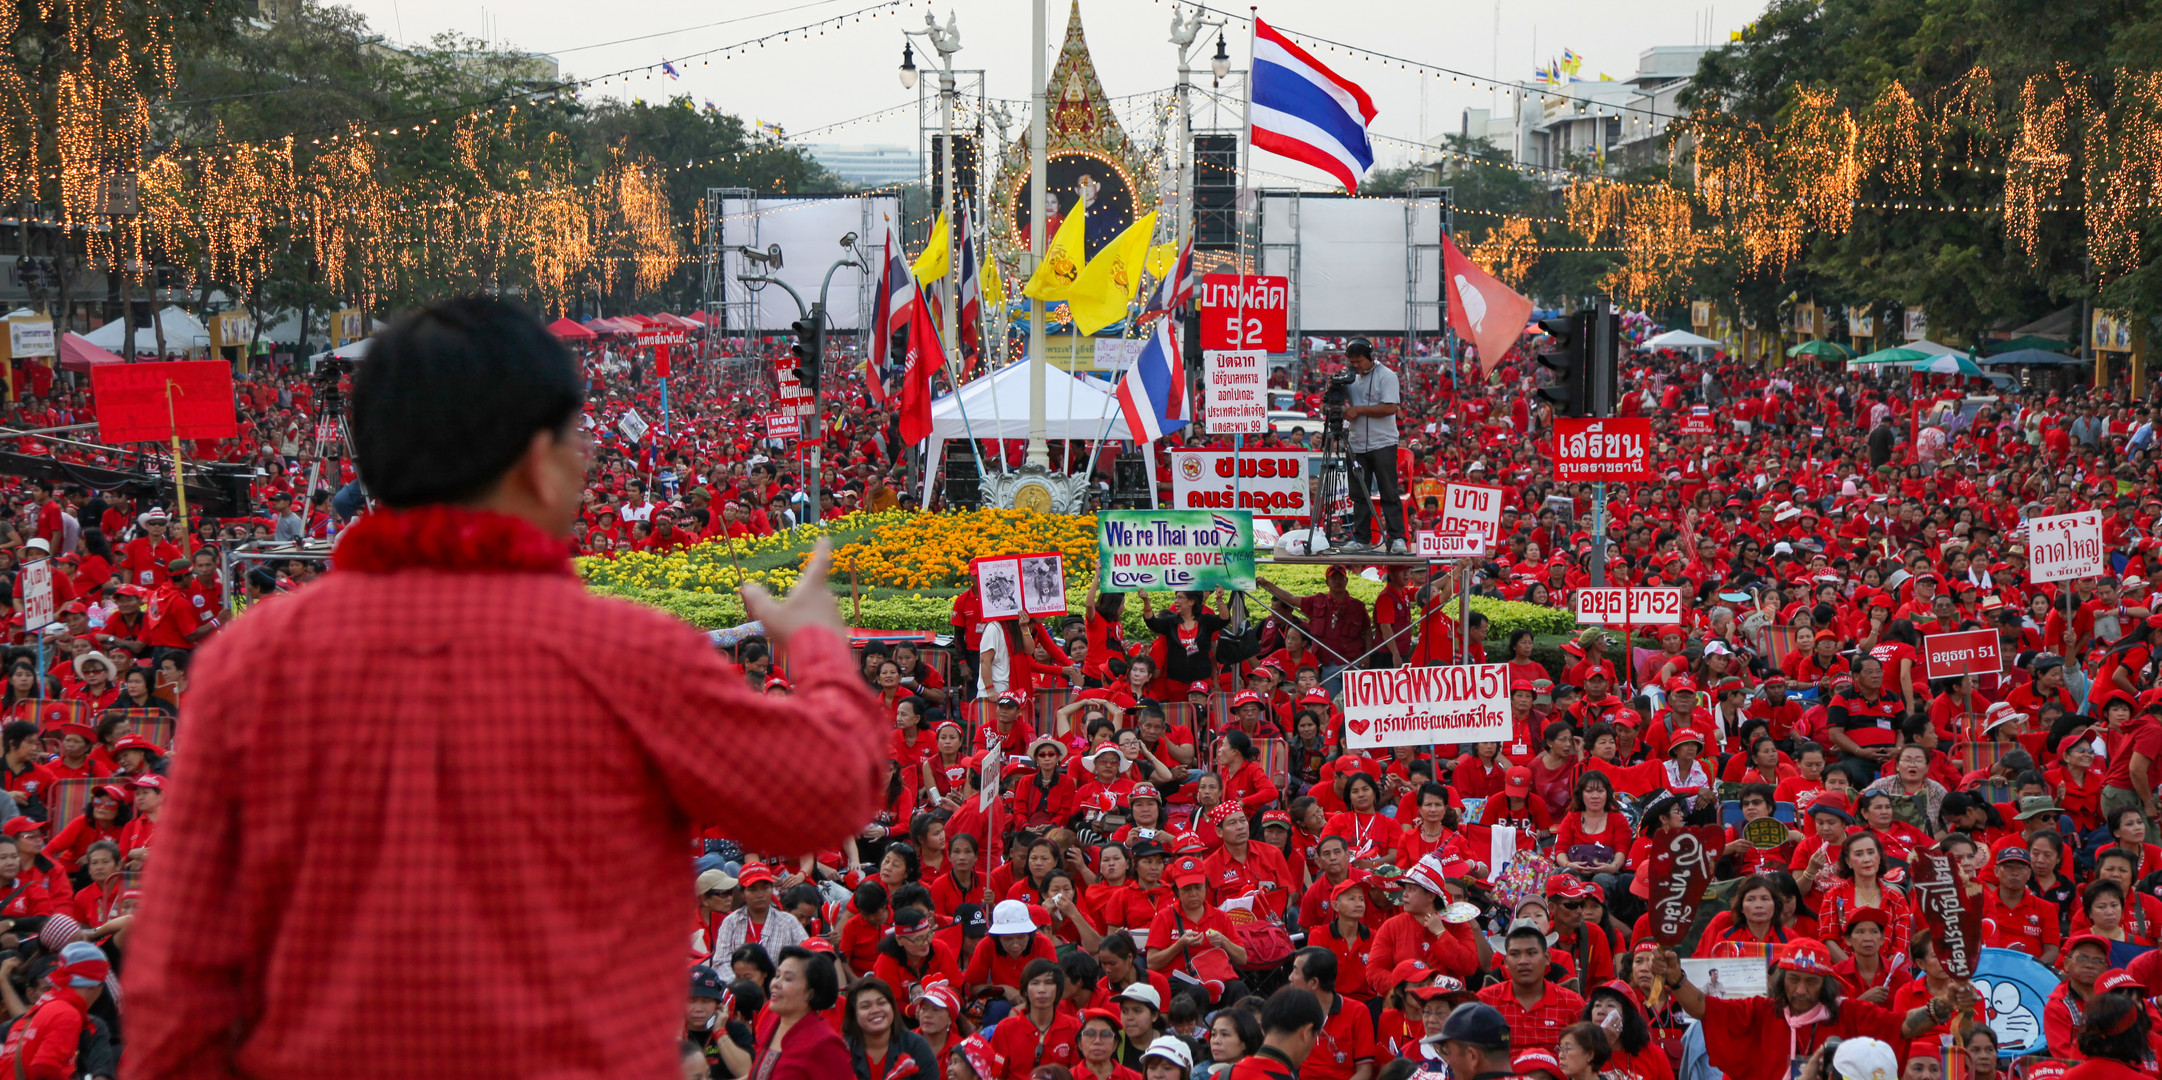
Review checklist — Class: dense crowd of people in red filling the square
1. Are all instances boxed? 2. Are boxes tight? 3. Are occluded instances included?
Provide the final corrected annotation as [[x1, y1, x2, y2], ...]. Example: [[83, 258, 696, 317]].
[[0, 300, 2162, 1080]]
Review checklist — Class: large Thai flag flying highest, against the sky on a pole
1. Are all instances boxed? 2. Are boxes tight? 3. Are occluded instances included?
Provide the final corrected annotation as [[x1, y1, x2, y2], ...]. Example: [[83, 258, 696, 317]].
[[1250, 19, 1373, 194]]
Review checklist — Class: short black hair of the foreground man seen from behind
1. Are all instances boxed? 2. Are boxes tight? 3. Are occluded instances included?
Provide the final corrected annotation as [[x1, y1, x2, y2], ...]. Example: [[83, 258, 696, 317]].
[[350, 296, 584, 508]]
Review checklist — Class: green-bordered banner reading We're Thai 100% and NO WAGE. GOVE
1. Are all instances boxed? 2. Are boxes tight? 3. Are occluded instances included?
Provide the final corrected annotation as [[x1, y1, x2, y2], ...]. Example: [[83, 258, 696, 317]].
[[1096, 510, 1254, 592]]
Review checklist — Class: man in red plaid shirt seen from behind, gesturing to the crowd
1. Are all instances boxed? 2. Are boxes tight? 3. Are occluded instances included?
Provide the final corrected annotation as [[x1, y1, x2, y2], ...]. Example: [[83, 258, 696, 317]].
[[128, 298, 886, 1080]]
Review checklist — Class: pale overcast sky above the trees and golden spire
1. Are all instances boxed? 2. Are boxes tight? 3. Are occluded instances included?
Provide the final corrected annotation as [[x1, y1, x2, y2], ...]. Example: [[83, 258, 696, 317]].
[[332, 0, 1762, 179]]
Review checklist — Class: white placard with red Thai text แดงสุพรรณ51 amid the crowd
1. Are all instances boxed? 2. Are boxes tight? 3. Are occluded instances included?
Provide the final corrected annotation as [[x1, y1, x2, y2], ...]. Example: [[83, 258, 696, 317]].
[[1343, 663, 1509, 750]]
